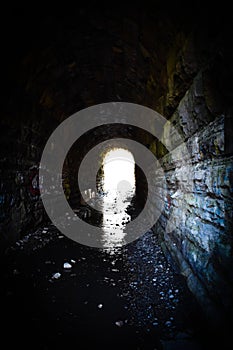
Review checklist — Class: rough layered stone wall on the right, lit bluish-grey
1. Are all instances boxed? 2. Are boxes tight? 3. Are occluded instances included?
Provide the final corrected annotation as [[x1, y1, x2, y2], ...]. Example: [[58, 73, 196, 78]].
[[155, 72, 233, 322]]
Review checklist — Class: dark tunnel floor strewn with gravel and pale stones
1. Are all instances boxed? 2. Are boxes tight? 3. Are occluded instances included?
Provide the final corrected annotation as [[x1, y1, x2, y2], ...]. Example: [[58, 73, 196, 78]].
[[1, 224, 215, 350]]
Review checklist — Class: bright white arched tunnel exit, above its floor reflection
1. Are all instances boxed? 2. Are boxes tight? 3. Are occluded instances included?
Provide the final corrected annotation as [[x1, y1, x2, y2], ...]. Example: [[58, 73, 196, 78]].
[[103, 148, 135, 192]]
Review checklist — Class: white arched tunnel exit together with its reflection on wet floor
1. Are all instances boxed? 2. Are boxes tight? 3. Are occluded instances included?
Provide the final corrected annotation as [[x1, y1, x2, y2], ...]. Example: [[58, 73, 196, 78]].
[[102, 149, 135, 250]]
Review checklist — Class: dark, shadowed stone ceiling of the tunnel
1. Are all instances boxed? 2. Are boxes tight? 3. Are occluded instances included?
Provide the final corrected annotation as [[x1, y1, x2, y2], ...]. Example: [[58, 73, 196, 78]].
[[3, 1, 232, 128]]
